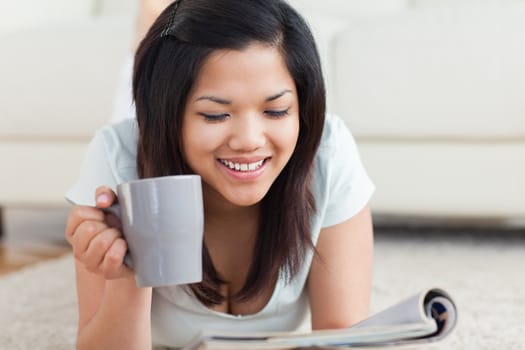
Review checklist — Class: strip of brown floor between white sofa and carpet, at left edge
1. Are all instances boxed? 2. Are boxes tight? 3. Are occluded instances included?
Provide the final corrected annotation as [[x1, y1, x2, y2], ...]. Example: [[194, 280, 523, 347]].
[[0, 208, 70, 275]]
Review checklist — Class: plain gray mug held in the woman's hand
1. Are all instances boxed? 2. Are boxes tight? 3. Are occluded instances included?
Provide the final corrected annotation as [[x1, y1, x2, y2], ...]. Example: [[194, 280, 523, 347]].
[[105, 175, 204, 287]]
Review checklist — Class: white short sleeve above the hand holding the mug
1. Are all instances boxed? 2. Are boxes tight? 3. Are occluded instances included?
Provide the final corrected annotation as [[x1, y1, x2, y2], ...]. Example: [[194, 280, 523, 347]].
[[65, 131, 117, 206]]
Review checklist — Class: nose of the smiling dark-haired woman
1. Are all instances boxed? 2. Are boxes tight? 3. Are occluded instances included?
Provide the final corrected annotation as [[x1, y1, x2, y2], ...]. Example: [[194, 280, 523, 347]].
[[229, 114, 266, 152]]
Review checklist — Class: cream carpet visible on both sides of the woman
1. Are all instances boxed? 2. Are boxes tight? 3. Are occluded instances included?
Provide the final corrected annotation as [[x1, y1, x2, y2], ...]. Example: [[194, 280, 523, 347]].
[[0, 232, 525, 350]]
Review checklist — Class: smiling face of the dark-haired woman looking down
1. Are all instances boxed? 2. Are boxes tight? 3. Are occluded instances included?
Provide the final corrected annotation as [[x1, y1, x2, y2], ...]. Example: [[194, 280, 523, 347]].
[[182, 44, 299, 206]]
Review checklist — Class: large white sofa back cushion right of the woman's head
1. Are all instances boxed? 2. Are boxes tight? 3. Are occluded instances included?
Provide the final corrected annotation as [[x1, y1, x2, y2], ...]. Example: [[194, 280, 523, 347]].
[[332, 4, 525, 140]]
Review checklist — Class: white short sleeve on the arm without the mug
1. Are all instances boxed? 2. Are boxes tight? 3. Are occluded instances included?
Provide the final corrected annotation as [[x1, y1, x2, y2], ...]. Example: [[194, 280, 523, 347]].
[[317, 115, 375, 227]]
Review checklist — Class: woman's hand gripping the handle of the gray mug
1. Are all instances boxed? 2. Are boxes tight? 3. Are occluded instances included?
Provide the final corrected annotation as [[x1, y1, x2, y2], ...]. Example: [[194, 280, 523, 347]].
[[66, 187, 134, 280]]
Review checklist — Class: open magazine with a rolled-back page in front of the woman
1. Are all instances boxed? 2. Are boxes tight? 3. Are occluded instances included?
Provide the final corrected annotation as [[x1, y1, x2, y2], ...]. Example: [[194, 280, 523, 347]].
[[183, 288, 457, 350]]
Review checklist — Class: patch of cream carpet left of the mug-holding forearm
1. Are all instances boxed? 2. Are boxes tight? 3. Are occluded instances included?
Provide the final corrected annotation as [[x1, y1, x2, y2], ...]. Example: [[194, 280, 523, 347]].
[[0, 255, 77, 350]]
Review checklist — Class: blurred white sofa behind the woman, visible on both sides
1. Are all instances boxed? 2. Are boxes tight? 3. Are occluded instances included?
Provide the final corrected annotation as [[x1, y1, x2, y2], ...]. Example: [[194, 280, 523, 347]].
[[0, 0, 525, 235]]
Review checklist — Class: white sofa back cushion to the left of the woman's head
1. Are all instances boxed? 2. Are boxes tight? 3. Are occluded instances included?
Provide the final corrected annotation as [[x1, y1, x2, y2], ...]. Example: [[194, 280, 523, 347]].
[[0, 18, 132, 141]]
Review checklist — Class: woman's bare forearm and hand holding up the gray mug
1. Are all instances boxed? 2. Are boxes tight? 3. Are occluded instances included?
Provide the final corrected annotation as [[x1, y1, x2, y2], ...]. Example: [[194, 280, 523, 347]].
[[66, 188, 151, 350]]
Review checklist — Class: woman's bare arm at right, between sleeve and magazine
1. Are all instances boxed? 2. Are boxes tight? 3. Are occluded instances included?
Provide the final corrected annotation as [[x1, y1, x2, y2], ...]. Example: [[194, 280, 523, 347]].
[[308, 206, 373, 329]]
